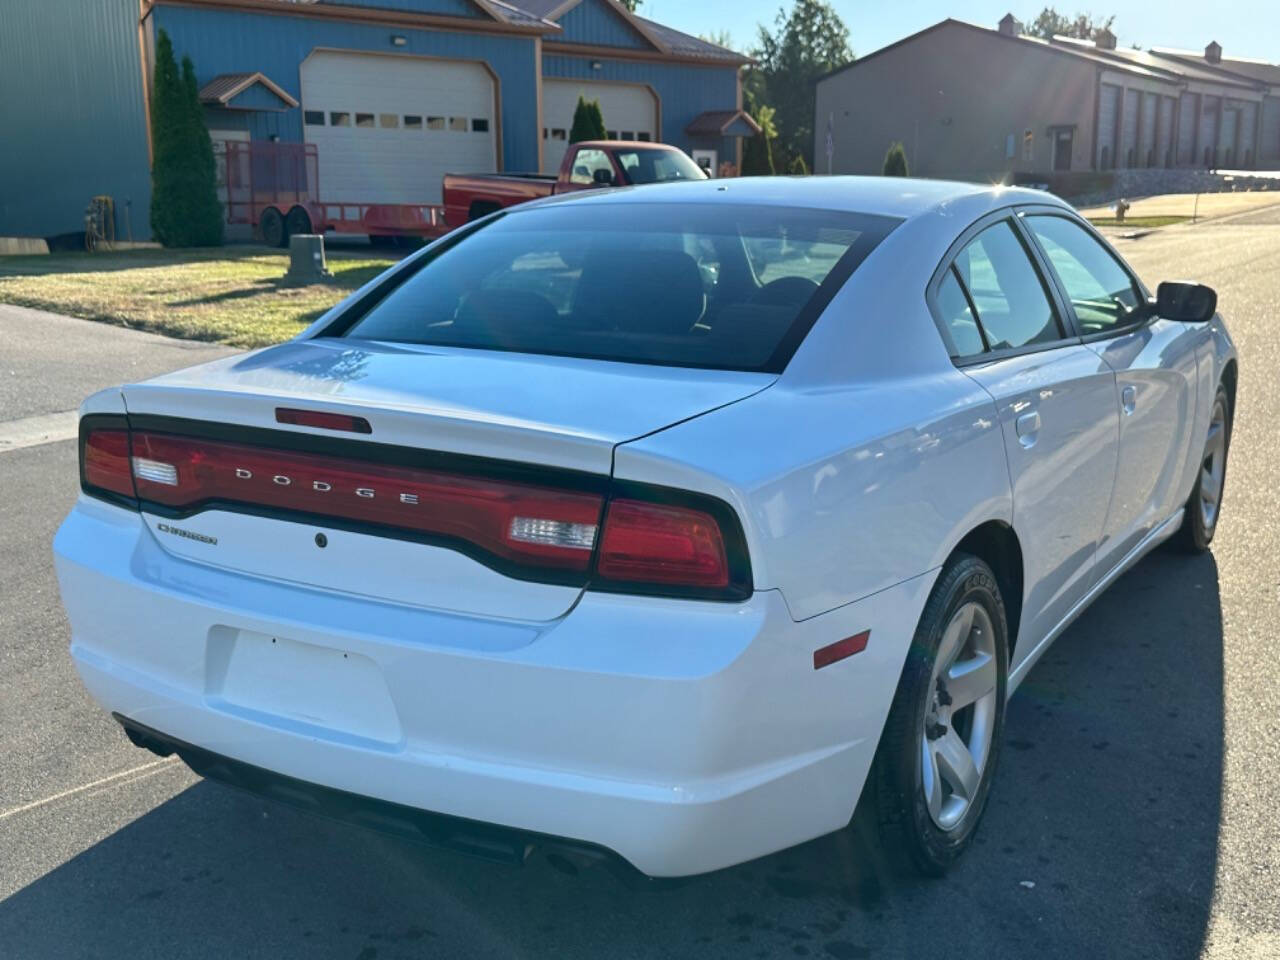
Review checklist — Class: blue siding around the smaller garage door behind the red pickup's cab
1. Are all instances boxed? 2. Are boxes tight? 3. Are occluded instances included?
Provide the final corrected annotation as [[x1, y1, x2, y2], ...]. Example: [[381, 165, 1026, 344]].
[[543, 54, 737, 159]]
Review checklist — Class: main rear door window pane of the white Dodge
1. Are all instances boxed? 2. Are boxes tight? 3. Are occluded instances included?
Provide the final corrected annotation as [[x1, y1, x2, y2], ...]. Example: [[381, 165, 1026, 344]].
[[955, 220, 1062, 349]]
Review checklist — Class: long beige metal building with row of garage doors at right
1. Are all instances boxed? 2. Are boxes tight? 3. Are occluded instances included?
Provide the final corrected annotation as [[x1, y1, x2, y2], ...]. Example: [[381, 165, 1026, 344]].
[[814, 14, 1280, 182]]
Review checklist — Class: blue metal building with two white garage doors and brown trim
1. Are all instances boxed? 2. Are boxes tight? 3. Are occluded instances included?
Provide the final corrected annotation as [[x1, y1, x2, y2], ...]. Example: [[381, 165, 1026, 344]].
[[0, 0, 753, 239]]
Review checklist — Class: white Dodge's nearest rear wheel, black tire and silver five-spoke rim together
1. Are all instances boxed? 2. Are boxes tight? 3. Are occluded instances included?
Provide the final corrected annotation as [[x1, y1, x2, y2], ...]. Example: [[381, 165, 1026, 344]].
[[869, 554, 1009, 876]]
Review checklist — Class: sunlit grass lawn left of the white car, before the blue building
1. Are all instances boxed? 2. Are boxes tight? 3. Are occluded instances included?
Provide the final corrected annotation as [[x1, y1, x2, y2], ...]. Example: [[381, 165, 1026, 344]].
[[0, 246, 393, 347]]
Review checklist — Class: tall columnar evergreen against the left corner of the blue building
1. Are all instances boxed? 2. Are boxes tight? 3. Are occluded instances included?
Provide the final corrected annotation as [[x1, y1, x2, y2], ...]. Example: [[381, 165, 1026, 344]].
[[151, 29, 223, 247]]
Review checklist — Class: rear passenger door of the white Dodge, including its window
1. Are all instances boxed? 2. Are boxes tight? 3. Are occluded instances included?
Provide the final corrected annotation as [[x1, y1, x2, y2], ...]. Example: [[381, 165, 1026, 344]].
[[931, 212, 1119, 668]]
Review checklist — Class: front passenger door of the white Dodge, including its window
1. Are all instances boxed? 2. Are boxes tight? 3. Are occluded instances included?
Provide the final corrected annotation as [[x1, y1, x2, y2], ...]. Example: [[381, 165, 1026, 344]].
[[1021, 209, 1204, 576]]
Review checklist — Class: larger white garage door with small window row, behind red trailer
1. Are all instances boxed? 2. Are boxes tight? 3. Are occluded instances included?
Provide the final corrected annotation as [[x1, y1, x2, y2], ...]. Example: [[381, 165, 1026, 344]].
[[302, 51, 498, 204]]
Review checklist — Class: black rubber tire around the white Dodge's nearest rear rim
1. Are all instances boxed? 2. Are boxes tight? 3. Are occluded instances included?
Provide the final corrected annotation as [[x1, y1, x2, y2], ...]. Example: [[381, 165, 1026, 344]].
[[868, 554, 1009, 877]]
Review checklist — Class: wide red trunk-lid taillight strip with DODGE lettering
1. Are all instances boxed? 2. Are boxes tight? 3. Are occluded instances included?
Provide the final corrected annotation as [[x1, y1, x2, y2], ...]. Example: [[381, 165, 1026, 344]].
[[133, 433, 604, 573]]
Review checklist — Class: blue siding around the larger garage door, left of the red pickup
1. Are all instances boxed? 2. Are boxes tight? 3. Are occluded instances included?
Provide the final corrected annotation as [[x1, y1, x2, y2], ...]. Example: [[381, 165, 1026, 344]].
[[152, 6, 541, 170]]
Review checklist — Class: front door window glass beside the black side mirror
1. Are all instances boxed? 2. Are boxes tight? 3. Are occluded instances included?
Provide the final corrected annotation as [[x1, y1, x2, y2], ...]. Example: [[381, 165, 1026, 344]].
[[1025, 215, 1146, 335]]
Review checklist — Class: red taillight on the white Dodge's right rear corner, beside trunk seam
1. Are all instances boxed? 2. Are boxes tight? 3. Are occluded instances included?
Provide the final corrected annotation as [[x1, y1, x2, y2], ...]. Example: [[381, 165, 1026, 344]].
[[595, 499, 730, 590]]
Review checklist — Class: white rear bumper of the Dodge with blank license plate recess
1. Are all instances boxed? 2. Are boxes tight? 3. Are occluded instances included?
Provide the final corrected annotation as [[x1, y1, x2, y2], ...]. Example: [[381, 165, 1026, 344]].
[[54, 498, 933, 876]]
